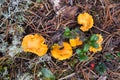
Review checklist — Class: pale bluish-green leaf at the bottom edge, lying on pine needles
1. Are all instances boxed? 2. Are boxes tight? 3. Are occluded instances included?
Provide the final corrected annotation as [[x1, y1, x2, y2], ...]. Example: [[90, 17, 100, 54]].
[[41, 68, 55, 80]]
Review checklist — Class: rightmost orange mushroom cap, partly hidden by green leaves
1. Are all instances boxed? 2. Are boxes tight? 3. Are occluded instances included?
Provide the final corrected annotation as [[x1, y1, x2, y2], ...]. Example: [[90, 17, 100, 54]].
[[89, 34, 103, 53]]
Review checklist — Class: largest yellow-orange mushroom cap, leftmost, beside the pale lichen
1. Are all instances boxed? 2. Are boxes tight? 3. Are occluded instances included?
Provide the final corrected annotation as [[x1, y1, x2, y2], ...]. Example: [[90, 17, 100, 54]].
[[22, 34, 48, 56]]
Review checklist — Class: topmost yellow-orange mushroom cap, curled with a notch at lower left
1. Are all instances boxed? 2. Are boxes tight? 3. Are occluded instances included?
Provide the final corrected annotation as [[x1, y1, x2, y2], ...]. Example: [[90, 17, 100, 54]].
[[77, 13, 94, 31]]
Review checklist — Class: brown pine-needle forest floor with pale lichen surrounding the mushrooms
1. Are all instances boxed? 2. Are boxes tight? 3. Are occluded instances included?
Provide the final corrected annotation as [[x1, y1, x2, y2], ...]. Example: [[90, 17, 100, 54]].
[[0, 0, 120, 80]]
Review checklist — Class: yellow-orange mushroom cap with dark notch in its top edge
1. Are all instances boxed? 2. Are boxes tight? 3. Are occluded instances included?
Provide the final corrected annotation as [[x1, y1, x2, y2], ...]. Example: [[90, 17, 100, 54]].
[[51, 42, 73, 60]]
